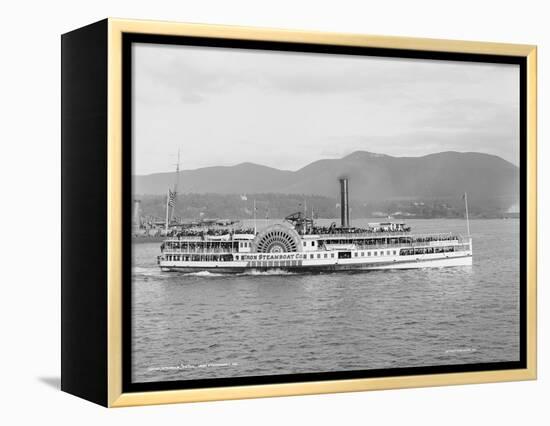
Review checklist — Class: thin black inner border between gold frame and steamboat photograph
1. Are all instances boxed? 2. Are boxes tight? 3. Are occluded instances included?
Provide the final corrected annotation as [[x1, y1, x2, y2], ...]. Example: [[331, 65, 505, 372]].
[[122, 33, 527, 393]]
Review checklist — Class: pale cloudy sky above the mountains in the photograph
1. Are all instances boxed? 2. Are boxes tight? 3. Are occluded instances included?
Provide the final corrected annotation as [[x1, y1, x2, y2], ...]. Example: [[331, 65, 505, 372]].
[[132, 44, 519, 175]]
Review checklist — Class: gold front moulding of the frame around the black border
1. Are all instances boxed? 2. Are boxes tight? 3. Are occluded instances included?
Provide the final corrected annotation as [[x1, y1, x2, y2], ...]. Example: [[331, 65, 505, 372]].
[[107, 18, 537, 407]]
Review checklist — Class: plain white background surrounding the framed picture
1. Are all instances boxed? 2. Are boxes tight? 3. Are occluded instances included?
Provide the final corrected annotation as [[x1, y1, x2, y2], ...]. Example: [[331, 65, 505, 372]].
[[0, 0, 550, 425]]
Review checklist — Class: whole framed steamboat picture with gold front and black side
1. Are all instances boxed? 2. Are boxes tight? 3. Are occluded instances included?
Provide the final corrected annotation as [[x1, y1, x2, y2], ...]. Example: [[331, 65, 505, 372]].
[[62, 19, 536, 406]]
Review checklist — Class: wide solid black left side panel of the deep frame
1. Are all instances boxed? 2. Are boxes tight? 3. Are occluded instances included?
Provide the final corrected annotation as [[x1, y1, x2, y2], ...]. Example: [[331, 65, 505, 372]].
[[61, 19, 108, 406]]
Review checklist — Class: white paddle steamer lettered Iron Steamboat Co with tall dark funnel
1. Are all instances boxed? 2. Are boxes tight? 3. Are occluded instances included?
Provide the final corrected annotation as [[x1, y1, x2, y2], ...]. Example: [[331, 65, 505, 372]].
[[157, 178, 472, 273]]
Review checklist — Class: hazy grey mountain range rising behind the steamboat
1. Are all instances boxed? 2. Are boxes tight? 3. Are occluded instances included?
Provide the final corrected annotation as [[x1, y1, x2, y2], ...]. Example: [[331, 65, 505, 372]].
[[134, 151, 519, 205]]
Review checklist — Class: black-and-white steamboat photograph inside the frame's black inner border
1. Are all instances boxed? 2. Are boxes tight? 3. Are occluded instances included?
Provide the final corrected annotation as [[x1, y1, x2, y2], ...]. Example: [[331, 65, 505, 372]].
[[130, 42, 523, 383]]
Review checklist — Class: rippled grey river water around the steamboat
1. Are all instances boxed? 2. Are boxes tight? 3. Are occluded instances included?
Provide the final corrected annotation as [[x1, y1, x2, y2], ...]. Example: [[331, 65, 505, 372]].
[[132, 220, 520, 382]]
